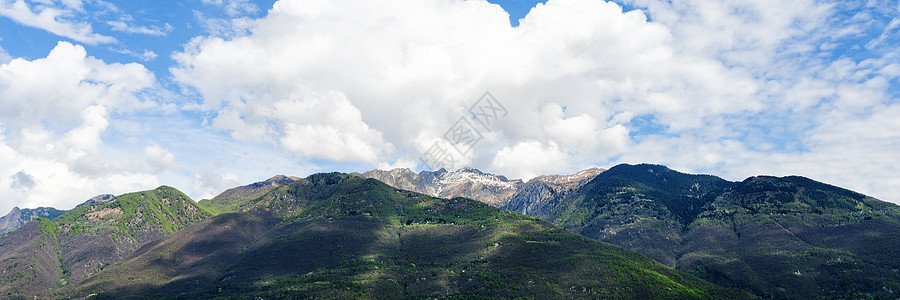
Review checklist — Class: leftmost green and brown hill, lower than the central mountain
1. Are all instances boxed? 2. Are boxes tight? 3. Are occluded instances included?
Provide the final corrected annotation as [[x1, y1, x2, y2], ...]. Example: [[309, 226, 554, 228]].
[[0, 186, 209, 298]]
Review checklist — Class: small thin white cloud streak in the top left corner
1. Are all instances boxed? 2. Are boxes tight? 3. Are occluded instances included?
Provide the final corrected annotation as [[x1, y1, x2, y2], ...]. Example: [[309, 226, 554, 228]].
[[0, 0, 116, 45]]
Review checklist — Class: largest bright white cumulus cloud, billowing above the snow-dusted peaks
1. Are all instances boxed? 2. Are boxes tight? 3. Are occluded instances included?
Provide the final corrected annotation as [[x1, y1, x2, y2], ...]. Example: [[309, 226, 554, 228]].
[[172, 1, 736, 169]]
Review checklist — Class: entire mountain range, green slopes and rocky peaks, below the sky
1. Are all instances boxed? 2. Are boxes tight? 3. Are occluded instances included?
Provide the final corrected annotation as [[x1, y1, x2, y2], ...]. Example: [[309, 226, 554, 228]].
[[0, 164, 900, 299]]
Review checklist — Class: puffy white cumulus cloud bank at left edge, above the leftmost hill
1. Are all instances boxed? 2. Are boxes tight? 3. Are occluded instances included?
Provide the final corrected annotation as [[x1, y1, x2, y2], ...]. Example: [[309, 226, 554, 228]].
[[0, 42, 178, 213]]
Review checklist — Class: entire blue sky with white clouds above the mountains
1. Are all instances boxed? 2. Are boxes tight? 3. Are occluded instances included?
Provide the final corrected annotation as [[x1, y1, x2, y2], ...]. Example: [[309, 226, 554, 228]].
[[0, 0, 900, 211]]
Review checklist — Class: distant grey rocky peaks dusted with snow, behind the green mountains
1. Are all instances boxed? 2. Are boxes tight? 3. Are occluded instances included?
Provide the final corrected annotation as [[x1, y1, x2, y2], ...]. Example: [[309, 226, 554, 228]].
[[354, 168, 603, 207]]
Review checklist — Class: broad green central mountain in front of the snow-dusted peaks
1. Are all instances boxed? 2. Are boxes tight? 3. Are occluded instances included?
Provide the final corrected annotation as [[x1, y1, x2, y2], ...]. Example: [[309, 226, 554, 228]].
[[52, 173, 753, 299]]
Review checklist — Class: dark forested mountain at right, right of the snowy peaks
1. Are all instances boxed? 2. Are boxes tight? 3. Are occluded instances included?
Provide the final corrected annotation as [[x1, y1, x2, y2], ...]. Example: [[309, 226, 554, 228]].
[[513, 164, 900, 298]]
